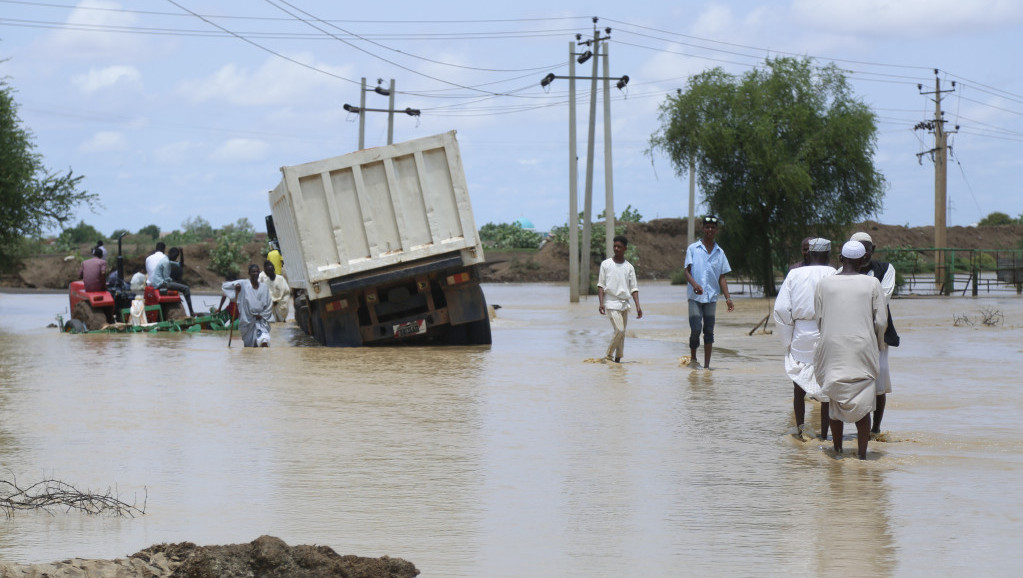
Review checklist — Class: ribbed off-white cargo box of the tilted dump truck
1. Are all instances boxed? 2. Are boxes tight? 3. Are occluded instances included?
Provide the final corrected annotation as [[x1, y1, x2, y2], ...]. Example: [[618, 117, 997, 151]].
[[270, 131, 484, 300]]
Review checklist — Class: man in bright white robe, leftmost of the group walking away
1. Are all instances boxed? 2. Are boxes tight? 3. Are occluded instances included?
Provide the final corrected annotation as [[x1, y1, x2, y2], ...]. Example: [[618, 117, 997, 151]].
[[774, 238, 835, 440]]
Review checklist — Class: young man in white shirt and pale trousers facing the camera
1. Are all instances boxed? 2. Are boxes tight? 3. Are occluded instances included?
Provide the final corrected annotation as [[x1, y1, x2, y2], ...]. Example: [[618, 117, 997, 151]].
[[596, 235, 642, 363]]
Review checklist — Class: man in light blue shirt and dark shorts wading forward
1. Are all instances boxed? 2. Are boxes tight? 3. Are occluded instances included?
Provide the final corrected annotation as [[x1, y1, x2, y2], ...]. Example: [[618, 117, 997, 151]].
[[685, 215, 735, 369]]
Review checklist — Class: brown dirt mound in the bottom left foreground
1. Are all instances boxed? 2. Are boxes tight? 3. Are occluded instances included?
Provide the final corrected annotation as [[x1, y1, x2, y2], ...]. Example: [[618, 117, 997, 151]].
[[0, 536, 419, 578]]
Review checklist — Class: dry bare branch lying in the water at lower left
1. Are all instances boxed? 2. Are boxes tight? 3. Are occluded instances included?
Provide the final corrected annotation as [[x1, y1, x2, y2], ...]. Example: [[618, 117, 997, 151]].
[[0, 479, 145, 518]]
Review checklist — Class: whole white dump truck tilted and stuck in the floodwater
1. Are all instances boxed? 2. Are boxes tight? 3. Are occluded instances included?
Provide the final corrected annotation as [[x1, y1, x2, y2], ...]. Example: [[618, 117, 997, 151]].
[[268, 131, 491, 347]]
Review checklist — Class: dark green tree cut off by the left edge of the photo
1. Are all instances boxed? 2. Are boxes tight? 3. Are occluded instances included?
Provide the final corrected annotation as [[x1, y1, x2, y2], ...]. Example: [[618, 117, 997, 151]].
[[0, 79, 99, 265]]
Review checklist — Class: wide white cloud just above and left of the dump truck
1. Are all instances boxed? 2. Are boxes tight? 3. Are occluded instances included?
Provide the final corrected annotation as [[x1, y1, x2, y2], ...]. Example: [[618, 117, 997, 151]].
[[177, 54, 358, 106]]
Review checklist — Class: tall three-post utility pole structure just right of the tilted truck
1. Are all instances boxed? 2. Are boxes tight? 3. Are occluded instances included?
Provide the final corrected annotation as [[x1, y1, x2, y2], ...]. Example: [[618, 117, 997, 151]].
[[540, 17, 629, 303]]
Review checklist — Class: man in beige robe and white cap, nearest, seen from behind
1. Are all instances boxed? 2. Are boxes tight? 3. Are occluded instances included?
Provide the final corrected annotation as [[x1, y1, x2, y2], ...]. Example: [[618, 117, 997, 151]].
[[813, 240, 888, 459]]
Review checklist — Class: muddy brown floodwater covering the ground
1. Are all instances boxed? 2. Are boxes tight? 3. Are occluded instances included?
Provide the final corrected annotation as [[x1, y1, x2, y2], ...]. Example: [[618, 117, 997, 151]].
[[0, 283, 1023, 578]]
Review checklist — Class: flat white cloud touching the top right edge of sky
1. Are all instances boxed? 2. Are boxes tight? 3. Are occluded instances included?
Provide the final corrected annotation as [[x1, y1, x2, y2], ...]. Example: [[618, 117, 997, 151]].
[[791, 0, 1023, 38]]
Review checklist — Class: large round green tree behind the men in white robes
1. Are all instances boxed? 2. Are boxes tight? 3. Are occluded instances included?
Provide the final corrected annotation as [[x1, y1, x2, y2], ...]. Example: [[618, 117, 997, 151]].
[[651, 58, 885, 296]]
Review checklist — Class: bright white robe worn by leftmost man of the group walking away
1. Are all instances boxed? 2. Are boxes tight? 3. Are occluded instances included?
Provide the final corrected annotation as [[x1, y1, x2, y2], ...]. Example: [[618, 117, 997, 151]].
[[774, 265, 835, 402]]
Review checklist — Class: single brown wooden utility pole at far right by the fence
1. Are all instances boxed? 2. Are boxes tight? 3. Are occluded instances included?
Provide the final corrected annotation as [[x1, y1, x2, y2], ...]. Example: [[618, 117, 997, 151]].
[[914, 69, 959, 295]]
